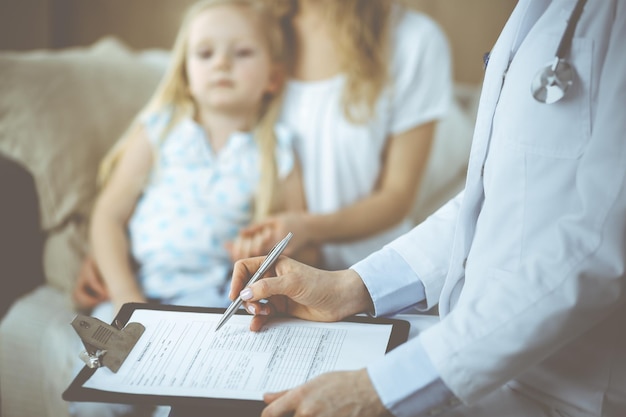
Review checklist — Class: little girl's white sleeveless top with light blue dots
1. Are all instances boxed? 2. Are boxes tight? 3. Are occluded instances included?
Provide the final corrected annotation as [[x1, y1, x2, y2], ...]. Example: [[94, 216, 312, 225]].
[[128, 111, 294, 307]]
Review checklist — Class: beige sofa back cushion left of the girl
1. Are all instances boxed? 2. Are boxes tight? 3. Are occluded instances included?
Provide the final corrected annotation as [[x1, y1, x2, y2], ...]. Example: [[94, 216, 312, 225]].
[[0, 38, 163, 291]]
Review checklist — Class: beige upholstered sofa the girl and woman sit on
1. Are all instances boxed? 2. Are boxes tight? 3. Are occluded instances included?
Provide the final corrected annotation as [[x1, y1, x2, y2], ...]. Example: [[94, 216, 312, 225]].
[[0, 37, 478, 417]]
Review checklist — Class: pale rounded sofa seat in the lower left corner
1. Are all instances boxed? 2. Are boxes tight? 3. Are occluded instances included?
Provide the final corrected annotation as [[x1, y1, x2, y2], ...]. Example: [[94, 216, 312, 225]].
[[0, 285, 77, 417]]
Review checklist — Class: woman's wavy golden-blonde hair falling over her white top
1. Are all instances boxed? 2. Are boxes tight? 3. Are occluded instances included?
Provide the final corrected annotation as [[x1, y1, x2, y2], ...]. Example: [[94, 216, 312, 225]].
[[263, 0, 394, 123]]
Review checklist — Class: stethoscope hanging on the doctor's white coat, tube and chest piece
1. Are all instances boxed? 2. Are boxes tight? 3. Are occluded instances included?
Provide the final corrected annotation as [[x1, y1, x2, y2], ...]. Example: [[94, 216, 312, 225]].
[[530, 0, 587, 104]]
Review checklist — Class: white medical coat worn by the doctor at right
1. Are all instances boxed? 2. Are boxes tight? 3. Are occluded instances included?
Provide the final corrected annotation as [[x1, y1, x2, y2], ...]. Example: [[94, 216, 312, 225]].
[[382, 0, 626, 417]]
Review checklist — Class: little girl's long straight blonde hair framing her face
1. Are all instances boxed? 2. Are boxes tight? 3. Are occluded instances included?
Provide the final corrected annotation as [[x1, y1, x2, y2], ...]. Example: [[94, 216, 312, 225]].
[[98, 0, 285, 219]]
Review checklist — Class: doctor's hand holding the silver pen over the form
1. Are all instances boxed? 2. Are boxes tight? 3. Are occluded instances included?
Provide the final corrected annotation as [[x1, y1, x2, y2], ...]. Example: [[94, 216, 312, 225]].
[[229, 256, 373, 331]]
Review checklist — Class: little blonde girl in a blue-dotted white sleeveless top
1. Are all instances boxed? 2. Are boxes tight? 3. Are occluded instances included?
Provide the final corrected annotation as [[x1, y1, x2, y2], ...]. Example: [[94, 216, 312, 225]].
[[90, 0, 305, 319]]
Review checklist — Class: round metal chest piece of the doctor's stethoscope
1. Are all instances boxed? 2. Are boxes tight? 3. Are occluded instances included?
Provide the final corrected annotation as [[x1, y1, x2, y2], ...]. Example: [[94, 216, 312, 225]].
[[530, 58, 574, 104]]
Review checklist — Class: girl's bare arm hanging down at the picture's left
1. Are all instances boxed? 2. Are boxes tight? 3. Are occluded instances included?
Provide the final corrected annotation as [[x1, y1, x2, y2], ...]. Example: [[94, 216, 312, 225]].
[[90, 129, 153, 311]]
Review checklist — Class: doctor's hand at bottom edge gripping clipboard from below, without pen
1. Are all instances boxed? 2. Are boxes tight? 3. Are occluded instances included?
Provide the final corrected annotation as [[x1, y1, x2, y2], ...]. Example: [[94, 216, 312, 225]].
[[261, 369, 391, 417]]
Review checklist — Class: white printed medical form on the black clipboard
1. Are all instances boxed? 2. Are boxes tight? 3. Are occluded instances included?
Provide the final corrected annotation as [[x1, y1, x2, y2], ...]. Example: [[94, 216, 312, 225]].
[[69, 308, 400, 400]]
